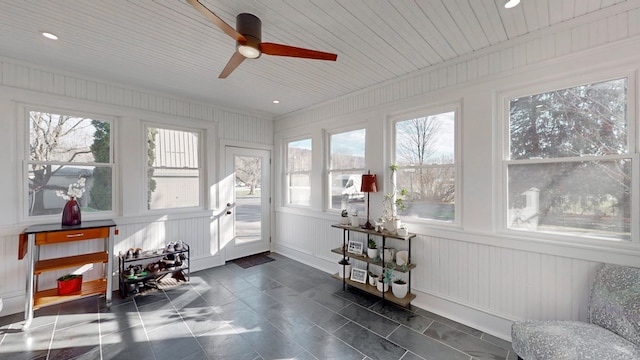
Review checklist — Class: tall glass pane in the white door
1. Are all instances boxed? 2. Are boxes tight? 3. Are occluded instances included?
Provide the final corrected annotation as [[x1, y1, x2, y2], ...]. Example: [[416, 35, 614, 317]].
[[234, 156, 262, 244]]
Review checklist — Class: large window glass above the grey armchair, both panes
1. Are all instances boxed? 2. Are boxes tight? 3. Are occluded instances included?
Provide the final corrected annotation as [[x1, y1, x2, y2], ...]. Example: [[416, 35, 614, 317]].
[[505, 79, 635, 240]]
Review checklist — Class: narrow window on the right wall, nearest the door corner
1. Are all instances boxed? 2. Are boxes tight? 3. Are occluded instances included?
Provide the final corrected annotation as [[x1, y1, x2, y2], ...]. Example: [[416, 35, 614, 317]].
[[287, 139, 312, 206]]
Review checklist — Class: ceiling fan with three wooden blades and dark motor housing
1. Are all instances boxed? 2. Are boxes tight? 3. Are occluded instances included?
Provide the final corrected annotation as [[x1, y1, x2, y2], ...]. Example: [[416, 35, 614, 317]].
[[187, 0, 338, 79]]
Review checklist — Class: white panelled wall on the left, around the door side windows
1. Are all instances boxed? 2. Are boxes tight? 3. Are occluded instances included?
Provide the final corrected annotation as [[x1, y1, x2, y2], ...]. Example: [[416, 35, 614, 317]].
[[0, 57, 273, 315]]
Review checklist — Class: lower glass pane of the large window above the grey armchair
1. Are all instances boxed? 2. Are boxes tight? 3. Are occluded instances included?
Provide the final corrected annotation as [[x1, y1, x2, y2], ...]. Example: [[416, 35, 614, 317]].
[[508, 159, 631, 240]]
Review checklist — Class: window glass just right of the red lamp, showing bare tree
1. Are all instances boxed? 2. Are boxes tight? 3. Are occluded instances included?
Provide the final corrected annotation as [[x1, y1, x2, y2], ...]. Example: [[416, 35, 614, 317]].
[[395, 111, 456, 222]]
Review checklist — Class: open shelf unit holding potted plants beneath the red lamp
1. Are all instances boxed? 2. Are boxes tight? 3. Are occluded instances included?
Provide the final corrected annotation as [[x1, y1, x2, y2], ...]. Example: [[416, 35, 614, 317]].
[[331, 224, 416, 307]]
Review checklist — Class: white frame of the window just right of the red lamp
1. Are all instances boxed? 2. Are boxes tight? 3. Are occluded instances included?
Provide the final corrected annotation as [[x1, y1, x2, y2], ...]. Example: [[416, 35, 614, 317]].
[[384, 102, 463, 228]]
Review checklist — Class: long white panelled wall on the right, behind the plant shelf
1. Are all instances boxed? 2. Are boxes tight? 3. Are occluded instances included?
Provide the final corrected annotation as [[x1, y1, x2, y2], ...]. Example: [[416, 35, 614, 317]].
[[274, 7, 640, 339]]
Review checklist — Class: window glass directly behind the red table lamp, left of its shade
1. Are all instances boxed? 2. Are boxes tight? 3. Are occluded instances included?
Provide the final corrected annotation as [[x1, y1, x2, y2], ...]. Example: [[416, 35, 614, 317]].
[[329, 129, 366, 213]]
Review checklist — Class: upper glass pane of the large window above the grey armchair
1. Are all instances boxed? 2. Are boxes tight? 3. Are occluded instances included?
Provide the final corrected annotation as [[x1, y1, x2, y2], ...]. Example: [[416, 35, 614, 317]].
[[509, 79, 629, 159]]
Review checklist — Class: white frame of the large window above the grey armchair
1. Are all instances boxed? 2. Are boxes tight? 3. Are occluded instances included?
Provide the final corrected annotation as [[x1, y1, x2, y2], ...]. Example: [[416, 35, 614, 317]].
[[493, 71, 640, 243]]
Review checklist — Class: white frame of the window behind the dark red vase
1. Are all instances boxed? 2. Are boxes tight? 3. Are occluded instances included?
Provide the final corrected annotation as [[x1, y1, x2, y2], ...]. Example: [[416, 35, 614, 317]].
[[17, 104, 118, 222]]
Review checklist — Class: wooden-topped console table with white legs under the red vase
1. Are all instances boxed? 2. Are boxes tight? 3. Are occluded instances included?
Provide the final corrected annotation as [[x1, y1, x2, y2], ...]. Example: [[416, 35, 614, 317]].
[[18, 220, 116, 329]]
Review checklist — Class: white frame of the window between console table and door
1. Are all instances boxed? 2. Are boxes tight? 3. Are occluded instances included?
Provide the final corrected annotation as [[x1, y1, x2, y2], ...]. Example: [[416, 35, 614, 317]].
[[146, 122, 208, 213]]
